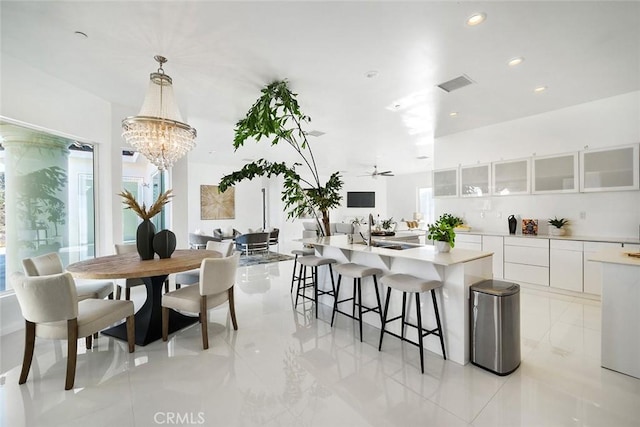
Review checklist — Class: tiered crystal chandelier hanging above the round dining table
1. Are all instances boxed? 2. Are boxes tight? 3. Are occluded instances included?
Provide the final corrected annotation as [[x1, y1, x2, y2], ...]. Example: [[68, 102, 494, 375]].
[[122, 55, 196, 170]]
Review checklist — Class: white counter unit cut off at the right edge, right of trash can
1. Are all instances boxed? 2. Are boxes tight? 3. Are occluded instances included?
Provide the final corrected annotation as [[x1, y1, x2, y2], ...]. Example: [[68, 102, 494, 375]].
[[590, 250, 640, 378]]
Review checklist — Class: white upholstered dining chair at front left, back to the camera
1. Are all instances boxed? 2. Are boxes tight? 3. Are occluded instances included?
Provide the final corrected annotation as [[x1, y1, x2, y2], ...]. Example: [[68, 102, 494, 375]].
[[11, 273, 135, 390]]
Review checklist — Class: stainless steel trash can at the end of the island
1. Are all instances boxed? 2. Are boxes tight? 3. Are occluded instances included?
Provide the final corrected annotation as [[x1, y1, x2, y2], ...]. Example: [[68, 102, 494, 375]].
[[469, 280, 520, 375]]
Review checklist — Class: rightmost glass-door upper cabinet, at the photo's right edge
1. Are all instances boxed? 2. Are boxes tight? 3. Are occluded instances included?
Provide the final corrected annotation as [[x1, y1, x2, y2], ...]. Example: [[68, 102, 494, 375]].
[[580, 144, 640, 192]]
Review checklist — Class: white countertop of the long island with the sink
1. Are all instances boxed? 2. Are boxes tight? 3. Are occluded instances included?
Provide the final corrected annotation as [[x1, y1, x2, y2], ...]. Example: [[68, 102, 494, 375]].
[[302, 235, 493, 266]]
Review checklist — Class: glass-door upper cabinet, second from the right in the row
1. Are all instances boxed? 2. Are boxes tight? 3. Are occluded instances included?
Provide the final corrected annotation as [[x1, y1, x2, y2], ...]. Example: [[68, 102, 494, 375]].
[[532, 153, 578, 194]]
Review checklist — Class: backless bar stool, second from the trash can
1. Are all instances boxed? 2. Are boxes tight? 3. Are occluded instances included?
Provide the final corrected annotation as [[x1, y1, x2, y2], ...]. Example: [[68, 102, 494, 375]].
[[331, 262, 382, 342]]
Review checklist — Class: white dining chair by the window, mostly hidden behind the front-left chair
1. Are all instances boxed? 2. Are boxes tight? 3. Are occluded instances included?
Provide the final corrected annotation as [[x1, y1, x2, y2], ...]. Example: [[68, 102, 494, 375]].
[[22, 252, 113, 301]]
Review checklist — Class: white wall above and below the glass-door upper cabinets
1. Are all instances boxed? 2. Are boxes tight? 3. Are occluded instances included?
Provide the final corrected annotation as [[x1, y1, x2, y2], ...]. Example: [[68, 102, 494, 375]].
[[434, 92, 640, 238]]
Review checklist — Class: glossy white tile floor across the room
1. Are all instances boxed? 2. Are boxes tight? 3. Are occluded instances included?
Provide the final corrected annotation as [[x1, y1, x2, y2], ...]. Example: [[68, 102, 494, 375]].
[[0, 261, 640, 427]]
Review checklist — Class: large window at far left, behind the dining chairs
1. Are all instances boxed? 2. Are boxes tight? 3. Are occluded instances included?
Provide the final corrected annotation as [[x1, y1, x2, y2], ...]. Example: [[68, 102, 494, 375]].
[[0, 122, 95, 291]]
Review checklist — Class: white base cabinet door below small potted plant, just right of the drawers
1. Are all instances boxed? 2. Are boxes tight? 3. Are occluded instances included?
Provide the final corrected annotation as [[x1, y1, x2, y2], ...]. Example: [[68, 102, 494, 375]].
[[549, 239, 583, 292]]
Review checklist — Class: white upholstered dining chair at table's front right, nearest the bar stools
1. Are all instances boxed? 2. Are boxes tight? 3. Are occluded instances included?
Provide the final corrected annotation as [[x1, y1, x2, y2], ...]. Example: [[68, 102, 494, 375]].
[[162, 253, 240, 350]]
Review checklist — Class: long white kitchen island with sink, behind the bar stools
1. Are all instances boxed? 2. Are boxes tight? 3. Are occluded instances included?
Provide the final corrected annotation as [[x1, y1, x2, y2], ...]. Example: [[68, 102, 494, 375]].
[[303, 235, 493, 365]]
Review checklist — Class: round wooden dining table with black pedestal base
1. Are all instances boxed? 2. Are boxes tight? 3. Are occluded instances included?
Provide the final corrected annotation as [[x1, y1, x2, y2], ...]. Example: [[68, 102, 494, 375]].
[[67, 249, 222, 346]]
